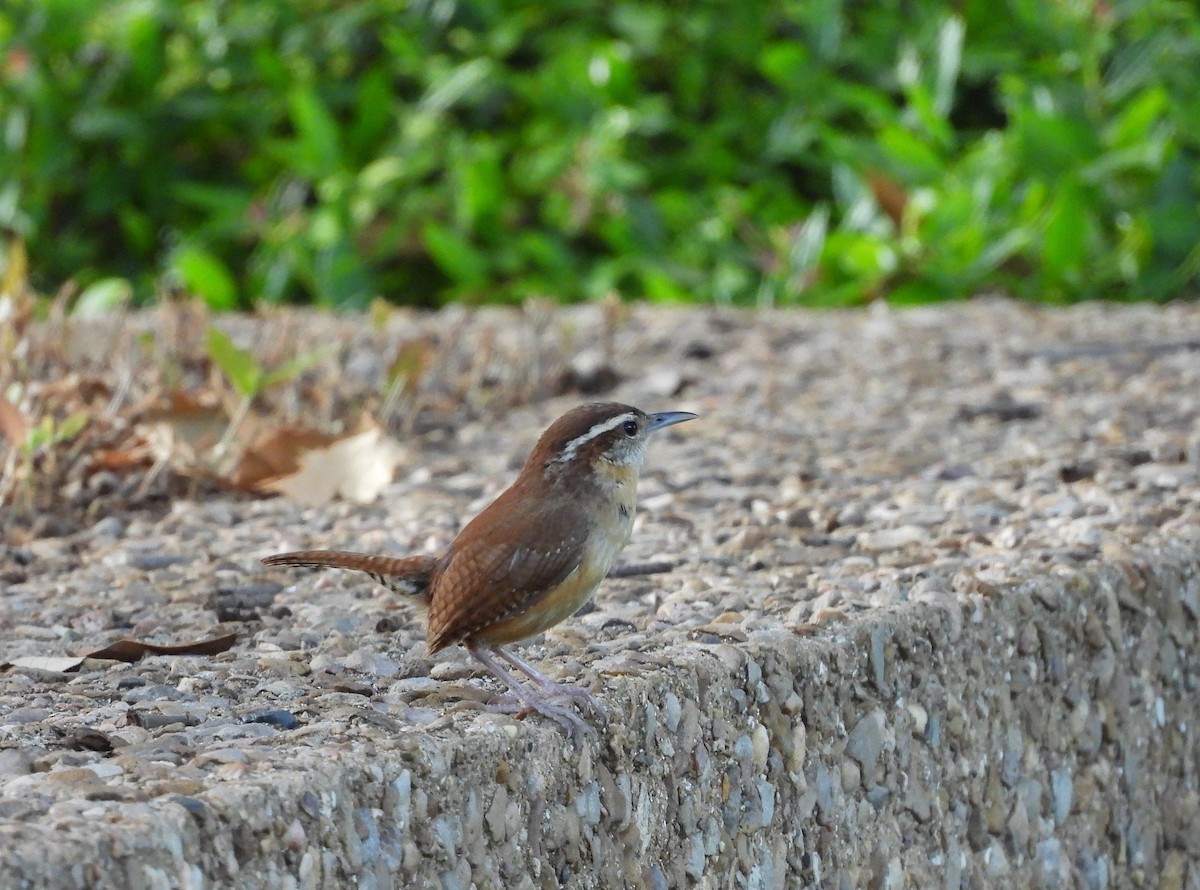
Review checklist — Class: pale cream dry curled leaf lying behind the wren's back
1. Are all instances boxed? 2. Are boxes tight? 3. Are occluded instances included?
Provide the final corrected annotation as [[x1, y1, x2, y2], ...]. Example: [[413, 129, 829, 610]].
[[262, 428, 404, 506]]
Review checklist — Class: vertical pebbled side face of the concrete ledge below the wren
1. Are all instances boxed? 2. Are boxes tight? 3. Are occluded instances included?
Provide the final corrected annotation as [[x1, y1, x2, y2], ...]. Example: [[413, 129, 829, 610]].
[[0, 546, 1200, 890]]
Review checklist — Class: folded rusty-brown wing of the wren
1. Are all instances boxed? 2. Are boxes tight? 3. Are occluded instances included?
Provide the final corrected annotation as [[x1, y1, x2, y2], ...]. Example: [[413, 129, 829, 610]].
[[428, 489, 586, 653]]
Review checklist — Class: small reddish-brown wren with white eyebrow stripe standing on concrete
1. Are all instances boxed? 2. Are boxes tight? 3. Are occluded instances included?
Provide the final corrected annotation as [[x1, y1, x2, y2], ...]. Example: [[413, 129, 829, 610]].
[[263, 403, 696, 734]]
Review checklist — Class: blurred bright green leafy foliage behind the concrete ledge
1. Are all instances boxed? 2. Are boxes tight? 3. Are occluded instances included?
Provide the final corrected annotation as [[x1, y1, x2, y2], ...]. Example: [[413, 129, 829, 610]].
[[0, 0, 1200, 308]]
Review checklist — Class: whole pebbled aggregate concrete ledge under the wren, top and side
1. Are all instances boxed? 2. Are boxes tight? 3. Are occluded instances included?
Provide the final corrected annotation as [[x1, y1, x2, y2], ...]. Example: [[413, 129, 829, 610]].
[[0, 300, 1200, 890]]
